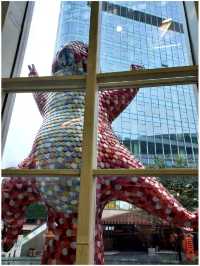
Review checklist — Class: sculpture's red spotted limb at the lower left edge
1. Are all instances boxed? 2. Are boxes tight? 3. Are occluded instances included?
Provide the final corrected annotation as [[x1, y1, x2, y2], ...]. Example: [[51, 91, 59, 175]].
[[2, 177, 40, 251]]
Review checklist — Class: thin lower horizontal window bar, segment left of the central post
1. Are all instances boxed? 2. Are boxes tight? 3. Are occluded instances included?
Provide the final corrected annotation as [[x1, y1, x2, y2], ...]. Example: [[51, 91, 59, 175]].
[[1, 168, 80, 177]]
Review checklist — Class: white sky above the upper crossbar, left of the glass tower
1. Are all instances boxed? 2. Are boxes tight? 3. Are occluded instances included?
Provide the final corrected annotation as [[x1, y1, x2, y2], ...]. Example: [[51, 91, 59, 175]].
[[21, 2, 60, 77]]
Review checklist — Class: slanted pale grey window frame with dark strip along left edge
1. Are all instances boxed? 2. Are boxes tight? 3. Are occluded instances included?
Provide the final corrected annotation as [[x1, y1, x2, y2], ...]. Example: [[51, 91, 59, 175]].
[[1, 1, 34, 155]]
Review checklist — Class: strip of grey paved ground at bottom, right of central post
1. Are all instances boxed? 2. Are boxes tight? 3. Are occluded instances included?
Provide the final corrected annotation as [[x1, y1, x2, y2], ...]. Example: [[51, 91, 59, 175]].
[[105, 251, 182, 265]]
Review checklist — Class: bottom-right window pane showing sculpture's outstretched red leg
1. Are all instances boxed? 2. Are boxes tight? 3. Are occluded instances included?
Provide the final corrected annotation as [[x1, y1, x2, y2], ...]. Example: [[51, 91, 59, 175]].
[[96, 175, 198, 265]]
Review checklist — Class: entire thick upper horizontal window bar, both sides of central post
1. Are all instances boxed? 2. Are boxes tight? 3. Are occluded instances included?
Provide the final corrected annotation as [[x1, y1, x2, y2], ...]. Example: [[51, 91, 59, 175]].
[[2, 65, 198, 93]]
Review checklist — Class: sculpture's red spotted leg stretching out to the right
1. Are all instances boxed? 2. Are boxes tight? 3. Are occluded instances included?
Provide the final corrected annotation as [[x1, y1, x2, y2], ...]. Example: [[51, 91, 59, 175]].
[[98, 129, 197, 228]]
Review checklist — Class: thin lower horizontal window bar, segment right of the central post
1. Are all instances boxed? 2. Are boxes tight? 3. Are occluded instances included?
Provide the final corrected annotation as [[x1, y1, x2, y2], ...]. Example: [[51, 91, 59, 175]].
[[93, 168, 198, 176]]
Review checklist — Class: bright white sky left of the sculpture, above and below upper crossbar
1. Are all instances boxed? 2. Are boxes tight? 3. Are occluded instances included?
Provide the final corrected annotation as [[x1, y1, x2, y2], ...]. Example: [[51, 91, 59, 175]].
[[2, 1, 60, 168]]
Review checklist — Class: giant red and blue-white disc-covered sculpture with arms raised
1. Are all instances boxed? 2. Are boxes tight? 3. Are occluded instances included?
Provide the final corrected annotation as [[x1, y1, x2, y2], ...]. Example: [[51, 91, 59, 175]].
[[2, 41, 197, 264]]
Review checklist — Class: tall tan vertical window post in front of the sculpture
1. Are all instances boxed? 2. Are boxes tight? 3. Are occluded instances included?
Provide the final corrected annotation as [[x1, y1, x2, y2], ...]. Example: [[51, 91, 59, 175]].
[[76, 1, 101, 264]]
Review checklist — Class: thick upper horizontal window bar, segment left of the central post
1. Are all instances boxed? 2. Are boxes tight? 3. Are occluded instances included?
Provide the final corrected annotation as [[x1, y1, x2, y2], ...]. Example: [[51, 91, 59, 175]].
[[2, 75, 86, 93]]
